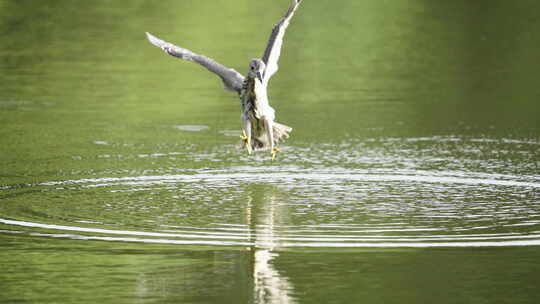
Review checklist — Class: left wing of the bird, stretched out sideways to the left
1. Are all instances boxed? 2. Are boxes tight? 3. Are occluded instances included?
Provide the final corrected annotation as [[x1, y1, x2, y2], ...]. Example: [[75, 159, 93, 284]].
[[146, 32, 244, 93]]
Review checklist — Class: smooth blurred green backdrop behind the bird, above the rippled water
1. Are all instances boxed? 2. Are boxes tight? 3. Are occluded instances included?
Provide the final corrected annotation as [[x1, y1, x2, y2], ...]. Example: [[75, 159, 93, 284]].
[[0, 0, 540, 183]]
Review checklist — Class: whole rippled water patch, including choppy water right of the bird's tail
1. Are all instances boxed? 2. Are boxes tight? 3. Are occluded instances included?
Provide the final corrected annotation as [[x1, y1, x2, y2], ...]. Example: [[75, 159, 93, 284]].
[[0, 138, 540, 248]]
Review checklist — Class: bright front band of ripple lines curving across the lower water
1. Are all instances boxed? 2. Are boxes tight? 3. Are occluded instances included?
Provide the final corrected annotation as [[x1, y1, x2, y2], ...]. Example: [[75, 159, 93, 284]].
[[0, 219, 540, 248]]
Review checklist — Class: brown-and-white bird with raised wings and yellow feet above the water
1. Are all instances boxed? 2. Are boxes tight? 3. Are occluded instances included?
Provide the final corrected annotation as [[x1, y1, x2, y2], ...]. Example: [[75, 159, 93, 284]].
[[146, 0, 302, 160]]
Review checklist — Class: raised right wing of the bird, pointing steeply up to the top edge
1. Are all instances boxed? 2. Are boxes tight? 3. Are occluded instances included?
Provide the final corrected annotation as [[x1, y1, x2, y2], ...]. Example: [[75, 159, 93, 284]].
[[262, 0, 302, 83]]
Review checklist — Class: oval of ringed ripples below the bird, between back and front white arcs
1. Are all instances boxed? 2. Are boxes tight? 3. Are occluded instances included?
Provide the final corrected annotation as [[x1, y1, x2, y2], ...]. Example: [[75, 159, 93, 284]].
[[0, 167, 540, 247]]
